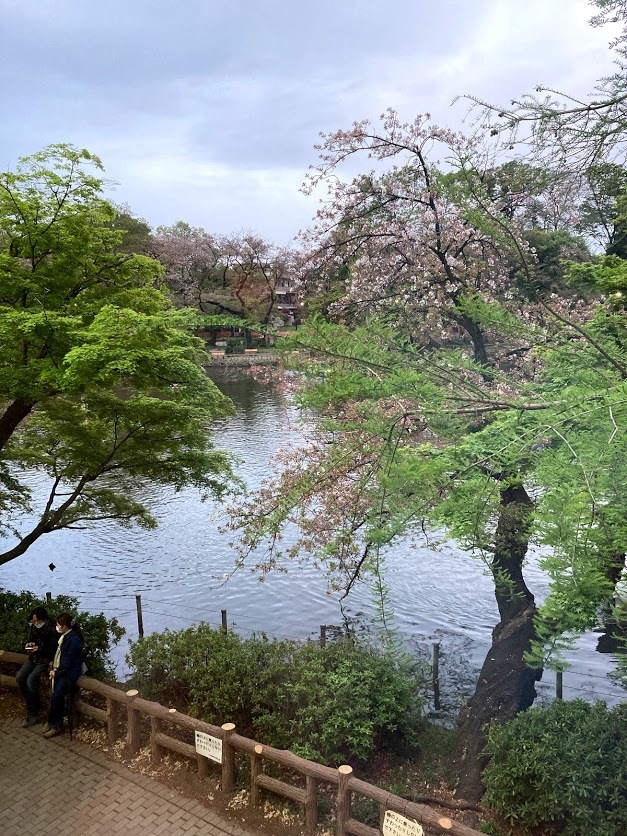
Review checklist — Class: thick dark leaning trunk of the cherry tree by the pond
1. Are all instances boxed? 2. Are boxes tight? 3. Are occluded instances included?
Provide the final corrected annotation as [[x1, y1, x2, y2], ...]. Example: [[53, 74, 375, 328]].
[[455, 485, 542, 803]]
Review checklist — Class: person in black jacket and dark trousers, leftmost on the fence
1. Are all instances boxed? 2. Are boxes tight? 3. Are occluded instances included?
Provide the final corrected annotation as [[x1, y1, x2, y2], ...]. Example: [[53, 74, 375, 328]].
[[15, 607, 59, 729]]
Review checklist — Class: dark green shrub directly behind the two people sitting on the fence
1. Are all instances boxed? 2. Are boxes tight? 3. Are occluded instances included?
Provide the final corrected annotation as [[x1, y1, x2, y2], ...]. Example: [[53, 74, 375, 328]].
[[0, 589, 125, 679]]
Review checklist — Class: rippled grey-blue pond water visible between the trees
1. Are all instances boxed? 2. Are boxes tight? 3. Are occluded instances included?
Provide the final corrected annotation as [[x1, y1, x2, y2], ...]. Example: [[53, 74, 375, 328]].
[[0, 368, 625, 705]]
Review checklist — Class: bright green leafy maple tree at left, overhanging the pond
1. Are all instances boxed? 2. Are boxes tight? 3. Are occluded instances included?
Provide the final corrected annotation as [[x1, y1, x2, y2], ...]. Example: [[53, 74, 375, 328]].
[[0, 145, 232, 564]]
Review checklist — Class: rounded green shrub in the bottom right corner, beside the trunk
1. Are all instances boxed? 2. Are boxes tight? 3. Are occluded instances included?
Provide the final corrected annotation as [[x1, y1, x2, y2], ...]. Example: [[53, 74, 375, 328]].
[[484, 700, 627, 836]]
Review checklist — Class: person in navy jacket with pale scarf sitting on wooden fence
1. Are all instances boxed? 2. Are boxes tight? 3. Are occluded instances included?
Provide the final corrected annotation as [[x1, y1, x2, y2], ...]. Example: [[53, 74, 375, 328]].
[[44, 612, 83, 738]]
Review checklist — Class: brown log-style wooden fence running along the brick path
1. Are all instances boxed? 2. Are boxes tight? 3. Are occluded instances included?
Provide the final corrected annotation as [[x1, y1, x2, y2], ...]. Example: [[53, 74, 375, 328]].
[[0, 650, 481, 836]]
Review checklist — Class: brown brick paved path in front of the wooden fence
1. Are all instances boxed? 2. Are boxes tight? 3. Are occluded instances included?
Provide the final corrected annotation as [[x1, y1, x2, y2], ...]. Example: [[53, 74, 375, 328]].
[[0, 718, 258, 836]]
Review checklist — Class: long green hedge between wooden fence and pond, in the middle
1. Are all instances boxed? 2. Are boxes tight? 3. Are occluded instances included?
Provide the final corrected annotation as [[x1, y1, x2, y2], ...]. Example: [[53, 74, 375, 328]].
[[127, 624, 423, 763]]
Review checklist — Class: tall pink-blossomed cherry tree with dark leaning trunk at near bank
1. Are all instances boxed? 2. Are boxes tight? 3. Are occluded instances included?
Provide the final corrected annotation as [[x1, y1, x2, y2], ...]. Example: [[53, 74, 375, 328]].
[[228, 111, 623, 800]]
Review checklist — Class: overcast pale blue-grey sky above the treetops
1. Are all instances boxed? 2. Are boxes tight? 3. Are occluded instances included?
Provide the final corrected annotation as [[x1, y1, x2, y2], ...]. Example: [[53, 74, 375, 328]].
[[0, 0, 611, 244]]
